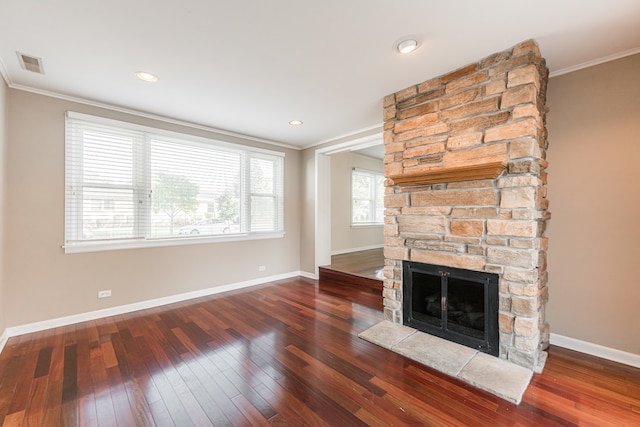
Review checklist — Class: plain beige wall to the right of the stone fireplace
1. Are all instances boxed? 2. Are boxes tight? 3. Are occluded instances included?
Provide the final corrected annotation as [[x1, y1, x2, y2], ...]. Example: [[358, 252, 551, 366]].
[[547, 55, 640, 355]]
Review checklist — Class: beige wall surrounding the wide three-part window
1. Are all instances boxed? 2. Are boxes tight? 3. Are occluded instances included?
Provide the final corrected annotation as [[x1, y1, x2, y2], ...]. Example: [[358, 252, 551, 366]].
[[4, 89, 301, 327]]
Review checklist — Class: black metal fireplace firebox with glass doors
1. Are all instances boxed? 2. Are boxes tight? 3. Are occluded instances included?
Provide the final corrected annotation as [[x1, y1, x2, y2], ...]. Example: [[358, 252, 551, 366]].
[[402, 261, 499, 356]]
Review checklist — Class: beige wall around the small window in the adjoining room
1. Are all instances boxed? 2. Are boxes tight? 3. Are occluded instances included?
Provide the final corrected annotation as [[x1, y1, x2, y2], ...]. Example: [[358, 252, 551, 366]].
[[331, 152, 384, 253]]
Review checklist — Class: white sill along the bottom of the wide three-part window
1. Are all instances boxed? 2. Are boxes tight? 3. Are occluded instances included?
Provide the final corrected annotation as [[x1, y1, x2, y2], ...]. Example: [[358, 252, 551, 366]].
[[62, 232, 284, 254]]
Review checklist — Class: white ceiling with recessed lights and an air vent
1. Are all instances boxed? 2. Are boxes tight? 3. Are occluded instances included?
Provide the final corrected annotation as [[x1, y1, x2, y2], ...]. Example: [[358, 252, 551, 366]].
[[0, 0, 640, 147]]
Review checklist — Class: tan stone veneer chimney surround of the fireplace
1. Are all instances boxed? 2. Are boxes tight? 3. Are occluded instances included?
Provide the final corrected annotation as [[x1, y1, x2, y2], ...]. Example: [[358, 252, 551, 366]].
[[383, 40, 550, 371]]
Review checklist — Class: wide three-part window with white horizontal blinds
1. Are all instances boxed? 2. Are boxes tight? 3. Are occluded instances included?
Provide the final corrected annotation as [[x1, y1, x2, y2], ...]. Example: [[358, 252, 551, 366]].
[[65, 112, 284, 252]]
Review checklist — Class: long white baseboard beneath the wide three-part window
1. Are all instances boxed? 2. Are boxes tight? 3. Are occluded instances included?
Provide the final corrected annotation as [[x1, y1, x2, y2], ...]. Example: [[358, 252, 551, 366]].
[[0, 271, 304, 346]]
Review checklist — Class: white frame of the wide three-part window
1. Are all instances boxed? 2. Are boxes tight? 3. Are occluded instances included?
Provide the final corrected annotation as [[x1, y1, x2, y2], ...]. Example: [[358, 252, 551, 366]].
[[62, 111, 285, 253]]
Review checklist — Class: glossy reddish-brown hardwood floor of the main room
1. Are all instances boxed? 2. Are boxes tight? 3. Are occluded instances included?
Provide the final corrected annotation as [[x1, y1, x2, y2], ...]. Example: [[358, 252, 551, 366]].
[[0, 278, 640, 426]]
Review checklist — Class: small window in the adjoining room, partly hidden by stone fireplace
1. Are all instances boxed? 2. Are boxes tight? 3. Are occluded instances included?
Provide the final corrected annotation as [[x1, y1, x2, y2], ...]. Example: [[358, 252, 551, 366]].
[[351, 169, 384, 225]]
